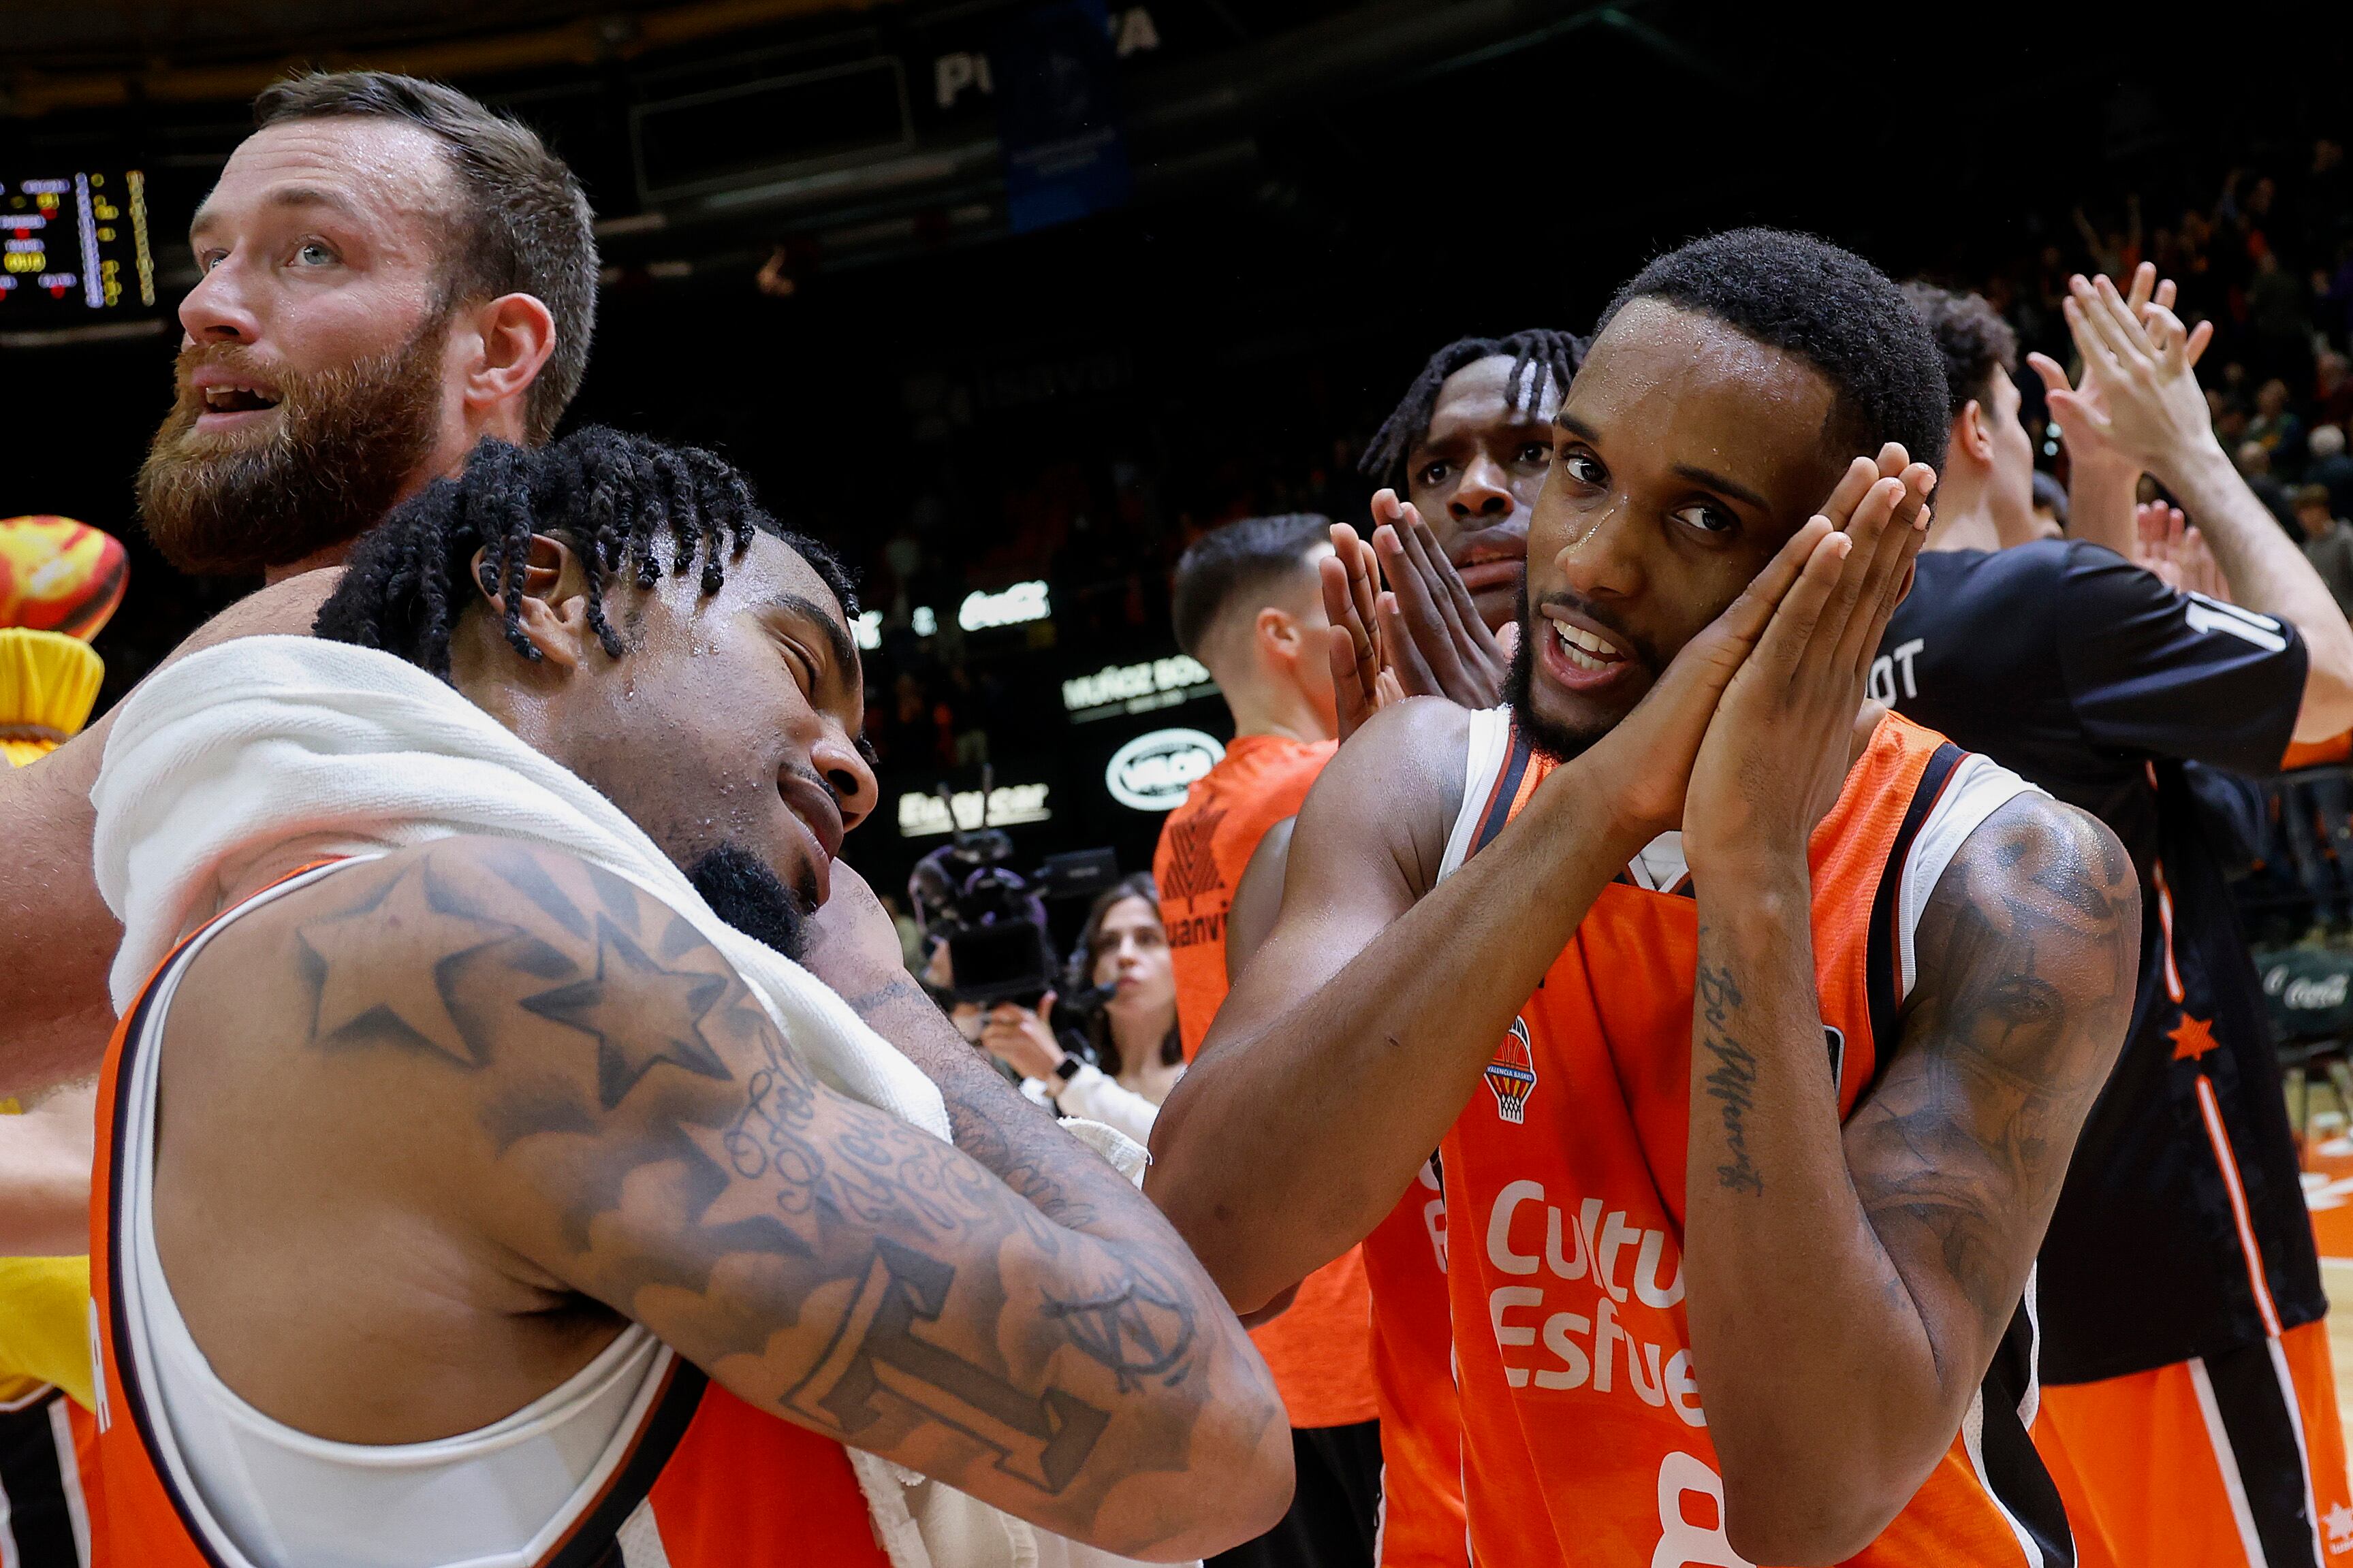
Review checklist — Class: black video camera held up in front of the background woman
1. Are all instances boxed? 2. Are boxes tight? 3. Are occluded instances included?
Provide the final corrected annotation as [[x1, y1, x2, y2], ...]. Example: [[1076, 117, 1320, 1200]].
[[906, 778, 1120, 1011]]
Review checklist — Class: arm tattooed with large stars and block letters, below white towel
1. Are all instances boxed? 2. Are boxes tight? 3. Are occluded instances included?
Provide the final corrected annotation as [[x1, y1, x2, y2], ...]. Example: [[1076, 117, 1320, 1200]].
[[257, 839, 1289, 1558]]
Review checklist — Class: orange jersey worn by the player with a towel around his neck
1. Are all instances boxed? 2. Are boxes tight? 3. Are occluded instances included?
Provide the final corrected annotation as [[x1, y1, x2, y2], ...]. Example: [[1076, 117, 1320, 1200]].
[[82, 867, 887, 1568]]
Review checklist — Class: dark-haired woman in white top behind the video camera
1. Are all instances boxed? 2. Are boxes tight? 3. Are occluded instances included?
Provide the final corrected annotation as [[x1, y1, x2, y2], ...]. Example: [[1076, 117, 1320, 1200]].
[[981, 872, 1184, 1142]]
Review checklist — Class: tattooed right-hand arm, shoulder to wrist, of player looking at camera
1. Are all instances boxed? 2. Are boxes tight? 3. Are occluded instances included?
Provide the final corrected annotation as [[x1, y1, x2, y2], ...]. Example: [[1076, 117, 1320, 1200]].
[[1685, 797, 2139, 1563]]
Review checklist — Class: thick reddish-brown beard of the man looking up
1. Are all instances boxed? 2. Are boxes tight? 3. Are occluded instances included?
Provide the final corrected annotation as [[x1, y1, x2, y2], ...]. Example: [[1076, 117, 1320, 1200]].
[[139, 310, 449, 573]]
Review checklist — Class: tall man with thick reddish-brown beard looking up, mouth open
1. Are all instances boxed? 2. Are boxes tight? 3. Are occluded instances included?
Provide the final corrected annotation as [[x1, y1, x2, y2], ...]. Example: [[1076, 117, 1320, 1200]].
[[0, 71, 598, 1093]]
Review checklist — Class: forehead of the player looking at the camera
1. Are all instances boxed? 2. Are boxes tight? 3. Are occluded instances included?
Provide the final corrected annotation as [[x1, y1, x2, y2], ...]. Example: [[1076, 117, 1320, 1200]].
[[1560, 299, 1854, 519]]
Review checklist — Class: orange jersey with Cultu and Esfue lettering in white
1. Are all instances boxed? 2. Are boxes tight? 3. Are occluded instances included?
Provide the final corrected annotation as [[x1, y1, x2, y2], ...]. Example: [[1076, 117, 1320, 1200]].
[[1440, 710, 2073, 1568]]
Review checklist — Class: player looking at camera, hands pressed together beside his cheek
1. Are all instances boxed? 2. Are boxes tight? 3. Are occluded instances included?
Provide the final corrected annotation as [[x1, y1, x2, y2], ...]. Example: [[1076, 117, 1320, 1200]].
[[1146, 230, 2139, 1568]]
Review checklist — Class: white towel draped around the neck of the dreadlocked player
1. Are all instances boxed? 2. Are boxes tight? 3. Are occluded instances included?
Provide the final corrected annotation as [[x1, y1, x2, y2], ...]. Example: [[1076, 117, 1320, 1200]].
[[89, 637, 1176, 1568]]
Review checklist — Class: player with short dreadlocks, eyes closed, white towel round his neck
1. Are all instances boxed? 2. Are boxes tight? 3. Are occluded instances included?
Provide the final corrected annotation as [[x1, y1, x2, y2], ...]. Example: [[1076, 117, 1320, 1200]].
[[78, 428, 1289, 1568]]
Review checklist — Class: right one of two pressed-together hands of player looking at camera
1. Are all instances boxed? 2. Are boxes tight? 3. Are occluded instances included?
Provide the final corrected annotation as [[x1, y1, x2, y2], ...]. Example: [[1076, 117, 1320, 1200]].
[[1682, 442, 1936, 877]]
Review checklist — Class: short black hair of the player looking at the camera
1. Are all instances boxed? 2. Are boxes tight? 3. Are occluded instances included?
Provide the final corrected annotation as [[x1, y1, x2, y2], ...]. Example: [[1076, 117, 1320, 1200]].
[[1593, 228, 1951, 468]]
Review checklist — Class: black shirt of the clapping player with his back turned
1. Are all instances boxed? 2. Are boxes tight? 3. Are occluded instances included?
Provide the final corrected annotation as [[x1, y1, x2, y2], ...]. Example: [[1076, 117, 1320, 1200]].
[[1871, 541, 2327, 1382]]
